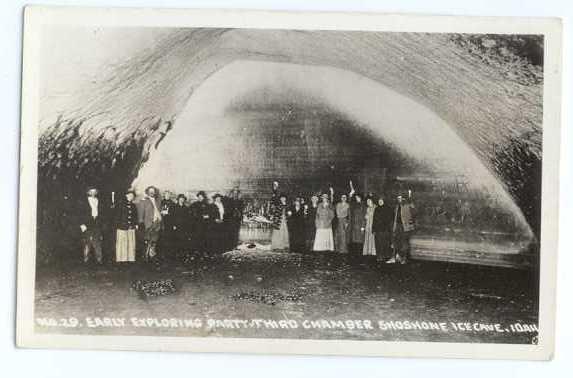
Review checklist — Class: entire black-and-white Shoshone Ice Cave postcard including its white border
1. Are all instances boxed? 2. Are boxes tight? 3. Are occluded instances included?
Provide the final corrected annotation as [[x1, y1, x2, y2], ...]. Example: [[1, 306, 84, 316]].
[[17, 6, 562, 359]]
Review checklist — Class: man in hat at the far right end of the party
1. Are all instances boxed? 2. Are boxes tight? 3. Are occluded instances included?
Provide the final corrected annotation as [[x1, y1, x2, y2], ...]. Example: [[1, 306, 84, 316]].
[[387, 190, 416, 264]]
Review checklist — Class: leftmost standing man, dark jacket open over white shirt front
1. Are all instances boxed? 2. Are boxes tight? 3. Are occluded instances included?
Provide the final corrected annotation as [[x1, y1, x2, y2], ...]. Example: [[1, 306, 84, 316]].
[[78, 188, 104, 264]]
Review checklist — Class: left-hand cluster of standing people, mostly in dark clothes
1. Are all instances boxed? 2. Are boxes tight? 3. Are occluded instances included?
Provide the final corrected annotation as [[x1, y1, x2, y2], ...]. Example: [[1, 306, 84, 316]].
[[77, 186, 242, 264]]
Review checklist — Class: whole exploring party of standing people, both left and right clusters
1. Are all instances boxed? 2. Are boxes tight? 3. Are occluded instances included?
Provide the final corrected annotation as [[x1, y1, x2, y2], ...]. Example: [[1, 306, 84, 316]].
[[78, 181, 416, 264]]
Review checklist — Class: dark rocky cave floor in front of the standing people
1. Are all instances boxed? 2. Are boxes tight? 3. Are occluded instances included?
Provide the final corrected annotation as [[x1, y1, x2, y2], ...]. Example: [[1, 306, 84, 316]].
[[35, 250, 537, 344]]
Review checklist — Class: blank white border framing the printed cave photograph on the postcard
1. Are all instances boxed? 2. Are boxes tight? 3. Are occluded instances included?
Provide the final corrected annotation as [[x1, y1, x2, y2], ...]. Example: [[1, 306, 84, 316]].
[[17, 6, 562, 360]]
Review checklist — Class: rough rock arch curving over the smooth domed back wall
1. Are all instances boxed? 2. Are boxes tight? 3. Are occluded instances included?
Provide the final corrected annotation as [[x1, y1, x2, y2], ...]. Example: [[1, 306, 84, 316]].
[[38, 29, 543, 262]]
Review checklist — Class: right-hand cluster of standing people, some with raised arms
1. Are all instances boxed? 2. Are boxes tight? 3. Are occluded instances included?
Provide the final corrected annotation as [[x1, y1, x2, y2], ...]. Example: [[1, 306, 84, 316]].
[[271, 181, 416, 264]]
